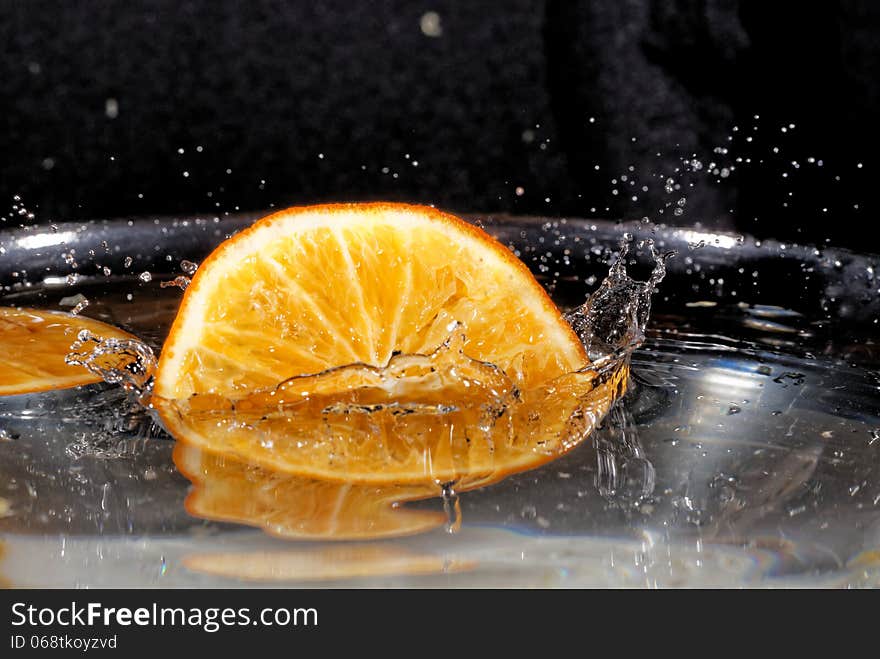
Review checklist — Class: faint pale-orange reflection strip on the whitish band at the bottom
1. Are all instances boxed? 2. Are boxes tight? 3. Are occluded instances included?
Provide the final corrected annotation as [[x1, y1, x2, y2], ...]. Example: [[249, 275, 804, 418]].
[[183, 544, 477, 581]]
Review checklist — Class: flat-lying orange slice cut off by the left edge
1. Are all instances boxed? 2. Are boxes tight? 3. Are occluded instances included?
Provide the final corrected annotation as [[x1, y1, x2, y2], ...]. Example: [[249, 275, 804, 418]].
[[0, 307, 134, 396]]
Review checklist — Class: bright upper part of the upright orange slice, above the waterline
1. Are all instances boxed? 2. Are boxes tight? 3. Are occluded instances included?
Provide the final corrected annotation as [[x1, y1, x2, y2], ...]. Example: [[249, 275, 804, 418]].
[[155, 204, 587, 399]]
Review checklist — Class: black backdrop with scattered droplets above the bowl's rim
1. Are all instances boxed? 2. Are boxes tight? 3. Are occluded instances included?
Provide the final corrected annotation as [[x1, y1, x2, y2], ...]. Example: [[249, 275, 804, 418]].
[[0, 0, 880, 251]]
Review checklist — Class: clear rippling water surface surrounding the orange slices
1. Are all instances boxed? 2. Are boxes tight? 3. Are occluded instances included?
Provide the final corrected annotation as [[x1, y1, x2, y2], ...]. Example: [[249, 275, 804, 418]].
[[0, 221, 880, 586]]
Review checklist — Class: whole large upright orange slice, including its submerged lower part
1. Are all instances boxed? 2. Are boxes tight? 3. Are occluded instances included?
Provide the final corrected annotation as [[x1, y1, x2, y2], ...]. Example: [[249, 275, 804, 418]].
[[153, 203, 622, 485]]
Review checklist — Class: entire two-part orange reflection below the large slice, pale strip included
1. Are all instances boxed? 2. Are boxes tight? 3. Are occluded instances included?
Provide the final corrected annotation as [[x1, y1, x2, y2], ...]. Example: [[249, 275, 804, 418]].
[[174, 443, 476, 582]]
